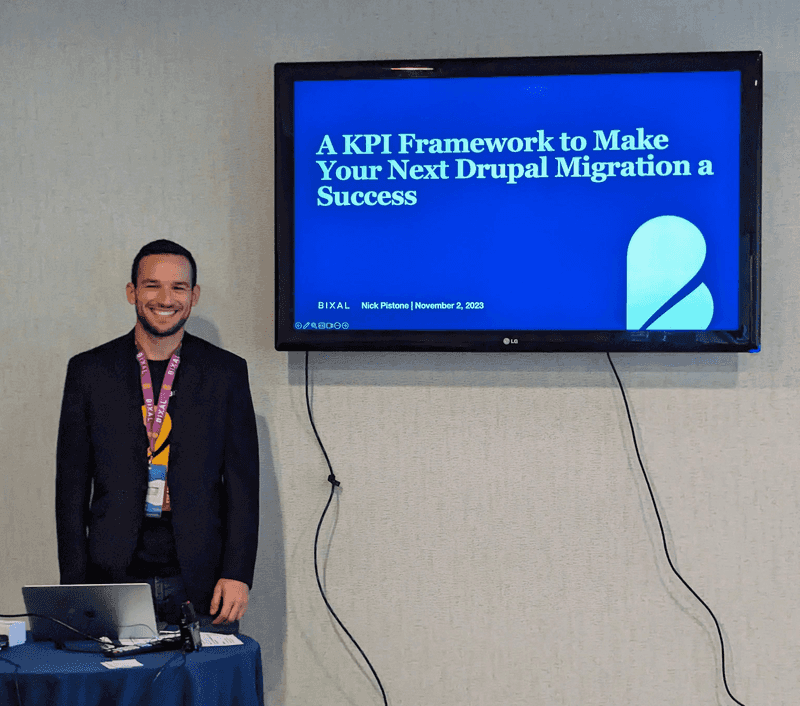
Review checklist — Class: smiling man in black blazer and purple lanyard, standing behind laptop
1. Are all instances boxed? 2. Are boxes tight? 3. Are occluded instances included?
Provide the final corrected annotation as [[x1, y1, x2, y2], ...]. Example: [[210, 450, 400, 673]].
[[56, 240, 258, 632]]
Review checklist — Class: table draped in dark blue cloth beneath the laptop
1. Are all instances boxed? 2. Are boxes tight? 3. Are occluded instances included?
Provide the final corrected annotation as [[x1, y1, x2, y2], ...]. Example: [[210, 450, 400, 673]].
[[0, 633, 264, 706]]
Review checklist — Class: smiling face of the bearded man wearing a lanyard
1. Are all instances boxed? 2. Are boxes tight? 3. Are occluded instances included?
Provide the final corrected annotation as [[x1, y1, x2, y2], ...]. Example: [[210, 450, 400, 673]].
[[126, 255, 200, 338]]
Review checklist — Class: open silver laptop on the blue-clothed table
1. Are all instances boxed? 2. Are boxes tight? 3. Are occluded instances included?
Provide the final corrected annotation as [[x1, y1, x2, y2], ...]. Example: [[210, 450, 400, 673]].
[[22, 583, 158, 642]]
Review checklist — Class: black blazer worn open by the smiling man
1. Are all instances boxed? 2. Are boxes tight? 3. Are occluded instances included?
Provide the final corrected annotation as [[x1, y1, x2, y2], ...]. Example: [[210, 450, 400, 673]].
[[56, 331, 258, 613]]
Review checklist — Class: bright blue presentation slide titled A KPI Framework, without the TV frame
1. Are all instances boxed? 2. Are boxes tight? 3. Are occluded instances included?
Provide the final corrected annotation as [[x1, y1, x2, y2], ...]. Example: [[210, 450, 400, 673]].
[[294, 71, 741, 330]]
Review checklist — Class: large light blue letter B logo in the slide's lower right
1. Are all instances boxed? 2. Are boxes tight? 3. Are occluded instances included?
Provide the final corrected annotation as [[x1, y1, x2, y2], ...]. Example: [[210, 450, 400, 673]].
[[627, 216, 714, 331]]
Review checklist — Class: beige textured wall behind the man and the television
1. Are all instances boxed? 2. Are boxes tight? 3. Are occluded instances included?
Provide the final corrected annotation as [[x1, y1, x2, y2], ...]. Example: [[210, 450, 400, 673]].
[[0, 0, 800, 706]]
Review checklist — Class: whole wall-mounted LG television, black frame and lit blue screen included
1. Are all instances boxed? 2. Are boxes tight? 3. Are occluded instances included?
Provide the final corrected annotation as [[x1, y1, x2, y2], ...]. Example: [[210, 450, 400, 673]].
[[275, 51, 762, 352]]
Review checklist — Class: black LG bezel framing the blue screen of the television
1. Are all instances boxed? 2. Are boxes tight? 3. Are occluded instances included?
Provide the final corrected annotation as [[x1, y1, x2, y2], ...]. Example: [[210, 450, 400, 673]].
[[275, 51, 763, 353]]
